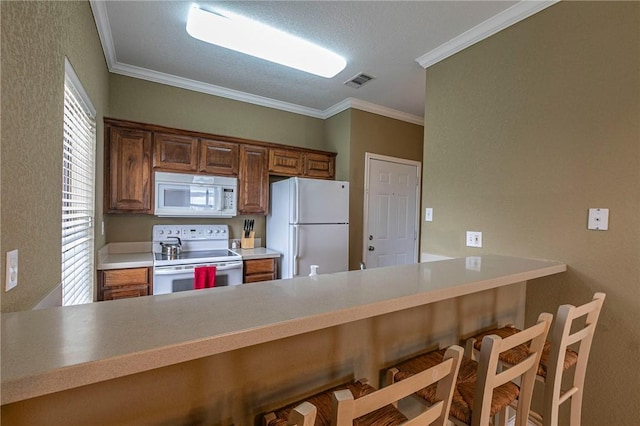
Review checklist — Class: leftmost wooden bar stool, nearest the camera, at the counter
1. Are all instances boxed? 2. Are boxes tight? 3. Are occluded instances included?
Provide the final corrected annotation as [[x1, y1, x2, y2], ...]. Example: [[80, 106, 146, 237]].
[[263, 346, 464, 426]]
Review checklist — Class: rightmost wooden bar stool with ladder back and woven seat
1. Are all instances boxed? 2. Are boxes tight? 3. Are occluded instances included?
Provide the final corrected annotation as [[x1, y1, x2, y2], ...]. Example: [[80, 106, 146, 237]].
[[467, 293, 606, 426]]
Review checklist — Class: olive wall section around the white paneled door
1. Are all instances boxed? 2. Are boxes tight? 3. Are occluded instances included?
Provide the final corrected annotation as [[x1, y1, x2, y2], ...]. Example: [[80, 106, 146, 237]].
[[349, 110, 423, 269]]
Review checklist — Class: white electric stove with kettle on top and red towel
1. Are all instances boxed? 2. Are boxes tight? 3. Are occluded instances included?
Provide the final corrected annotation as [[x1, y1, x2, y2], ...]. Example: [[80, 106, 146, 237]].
[[152, 225, 243, 295]]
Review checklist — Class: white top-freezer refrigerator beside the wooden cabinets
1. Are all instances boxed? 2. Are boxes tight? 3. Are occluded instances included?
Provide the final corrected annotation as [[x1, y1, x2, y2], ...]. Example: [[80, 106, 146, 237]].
[[266, 177, 349, 278]]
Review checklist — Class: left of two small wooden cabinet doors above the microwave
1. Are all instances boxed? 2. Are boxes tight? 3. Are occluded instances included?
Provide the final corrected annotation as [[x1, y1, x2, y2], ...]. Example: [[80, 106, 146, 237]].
[[153, 133, 198, 171]]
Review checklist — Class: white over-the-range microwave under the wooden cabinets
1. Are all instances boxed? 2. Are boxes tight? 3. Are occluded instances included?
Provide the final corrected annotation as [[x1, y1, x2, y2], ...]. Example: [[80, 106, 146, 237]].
[[154, 172, 238, 218]]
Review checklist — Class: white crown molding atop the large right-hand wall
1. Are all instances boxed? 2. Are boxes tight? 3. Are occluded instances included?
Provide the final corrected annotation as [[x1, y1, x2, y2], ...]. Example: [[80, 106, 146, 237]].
[[416, 0, 560, 68]]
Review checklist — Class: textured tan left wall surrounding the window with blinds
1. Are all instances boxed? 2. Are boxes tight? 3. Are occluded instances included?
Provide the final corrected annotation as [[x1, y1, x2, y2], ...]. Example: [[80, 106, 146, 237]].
[[0, 1, 108, 312]]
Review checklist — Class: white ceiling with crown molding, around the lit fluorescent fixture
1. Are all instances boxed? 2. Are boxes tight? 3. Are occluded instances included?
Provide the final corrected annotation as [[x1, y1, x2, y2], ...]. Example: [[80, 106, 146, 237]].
[[91, 0, 555, 124]]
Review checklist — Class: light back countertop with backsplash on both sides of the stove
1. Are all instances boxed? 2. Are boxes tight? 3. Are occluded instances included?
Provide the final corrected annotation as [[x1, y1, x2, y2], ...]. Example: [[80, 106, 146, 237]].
[[96, 242, 280, 271]]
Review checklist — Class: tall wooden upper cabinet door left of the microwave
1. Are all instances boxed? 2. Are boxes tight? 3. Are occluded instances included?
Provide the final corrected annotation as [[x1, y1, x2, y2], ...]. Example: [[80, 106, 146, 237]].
[[104, 127, 152, 214]]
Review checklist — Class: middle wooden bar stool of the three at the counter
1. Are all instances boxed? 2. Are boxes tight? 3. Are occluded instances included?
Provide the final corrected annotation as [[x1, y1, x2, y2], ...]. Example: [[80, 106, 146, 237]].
[[390, 313, 552, 426]]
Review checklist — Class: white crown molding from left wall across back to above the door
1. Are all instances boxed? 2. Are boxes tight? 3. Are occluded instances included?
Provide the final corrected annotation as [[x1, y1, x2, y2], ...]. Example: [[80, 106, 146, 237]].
[[89, 0, 424, 126]]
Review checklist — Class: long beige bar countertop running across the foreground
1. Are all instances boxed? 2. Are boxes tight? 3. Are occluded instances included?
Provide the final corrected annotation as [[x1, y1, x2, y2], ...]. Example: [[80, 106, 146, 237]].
[[1, 255, 566, 404]]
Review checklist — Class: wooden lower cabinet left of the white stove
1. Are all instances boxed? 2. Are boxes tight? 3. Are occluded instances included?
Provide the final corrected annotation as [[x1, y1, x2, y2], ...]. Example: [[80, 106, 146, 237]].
[[98, 268, 153, 301]]
